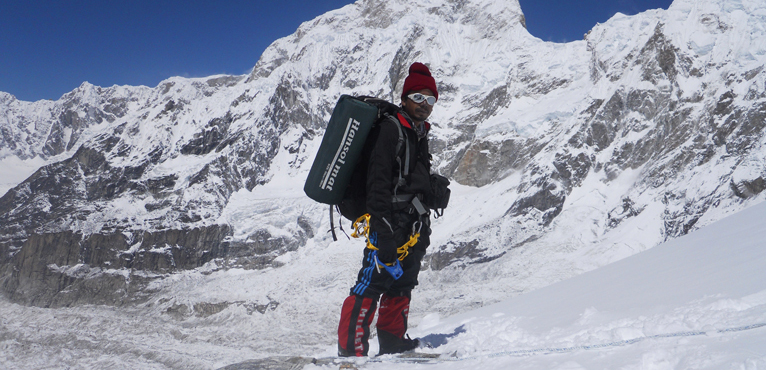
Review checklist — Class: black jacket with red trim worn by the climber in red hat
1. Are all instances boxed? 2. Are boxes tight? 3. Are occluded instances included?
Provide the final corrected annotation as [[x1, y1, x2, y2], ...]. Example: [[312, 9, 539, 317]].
[[366, 112, 431, 245]]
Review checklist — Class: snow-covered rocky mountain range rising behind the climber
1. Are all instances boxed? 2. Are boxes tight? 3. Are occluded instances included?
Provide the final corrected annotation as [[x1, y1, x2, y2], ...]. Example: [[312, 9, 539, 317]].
[[0, 0, 766, 364]]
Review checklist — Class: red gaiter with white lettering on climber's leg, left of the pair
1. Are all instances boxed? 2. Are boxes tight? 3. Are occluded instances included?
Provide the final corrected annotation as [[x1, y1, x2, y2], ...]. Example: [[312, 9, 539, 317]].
[[338, 294, 378, 357]]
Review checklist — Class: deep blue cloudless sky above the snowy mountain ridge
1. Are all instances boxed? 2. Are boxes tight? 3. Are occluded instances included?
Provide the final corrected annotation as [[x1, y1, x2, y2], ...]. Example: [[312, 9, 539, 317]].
[[0, 0, 671, 101]]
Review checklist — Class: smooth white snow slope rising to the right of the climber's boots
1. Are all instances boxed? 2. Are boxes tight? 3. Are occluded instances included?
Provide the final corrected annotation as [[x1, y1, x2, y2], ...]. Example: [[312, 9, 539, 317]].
[[306, 199, 766, 369]]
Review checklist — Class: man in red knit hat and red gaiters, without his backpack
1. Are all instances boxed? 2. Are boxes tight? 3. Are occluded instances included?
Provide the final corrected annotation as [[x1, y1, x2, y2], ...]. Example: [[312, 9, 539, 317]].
[[338, 63, 439, 356]]
